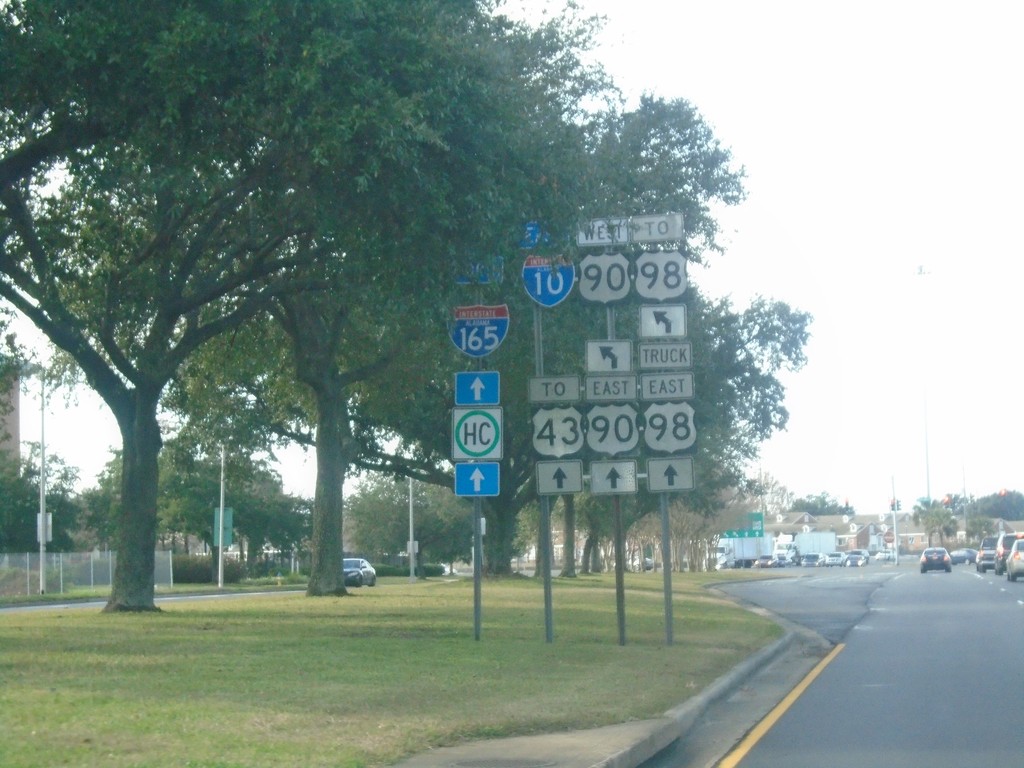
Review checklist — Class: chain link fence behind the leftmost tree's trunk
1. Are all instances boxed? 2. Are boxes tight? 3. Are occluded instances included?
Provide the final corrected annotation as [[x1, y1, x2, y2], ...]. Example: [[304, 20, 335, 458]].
[[0, 551, 174, 597]]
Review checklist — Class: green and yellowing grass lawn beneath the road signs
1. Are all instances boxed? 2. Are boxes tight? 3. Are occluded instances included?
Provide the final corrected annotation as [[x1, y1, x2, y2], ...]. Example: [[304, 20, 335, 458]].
[[0, 571, 781, 768]]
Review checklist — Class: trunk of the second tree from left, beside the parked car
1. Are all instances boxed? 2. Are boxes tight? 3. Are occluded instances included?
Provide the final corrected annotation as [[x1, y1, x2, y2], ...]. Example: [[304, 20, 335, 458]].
[[306, 391, 348, 597]]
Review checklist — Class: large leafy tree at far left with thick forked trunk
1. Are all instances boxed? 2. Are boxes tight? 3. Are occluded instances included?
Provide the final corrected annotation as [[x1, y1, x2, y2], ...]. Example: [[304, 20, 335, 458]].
[[0, 0, 606, 610]]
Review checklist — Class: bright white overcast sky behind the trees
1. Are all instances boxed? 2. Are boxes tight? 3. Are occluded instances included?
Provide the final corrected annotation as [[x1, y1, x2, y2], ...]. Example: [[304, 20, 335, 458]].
[[12, 0, 1024, 514]]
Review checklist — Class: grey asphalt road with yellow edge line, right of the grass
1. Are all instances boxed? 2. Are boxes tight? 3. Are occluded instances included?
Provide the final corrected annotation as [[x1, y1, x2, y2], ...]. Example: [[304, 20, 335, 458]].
[[645, 562, 1024, 768]]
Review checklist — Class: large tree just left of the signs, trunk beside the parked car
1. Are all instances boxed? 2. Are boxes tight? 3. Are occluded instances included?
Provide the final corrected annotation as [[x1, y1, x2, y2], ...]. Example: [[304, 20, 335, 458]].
[[164, 4, 603, 595]]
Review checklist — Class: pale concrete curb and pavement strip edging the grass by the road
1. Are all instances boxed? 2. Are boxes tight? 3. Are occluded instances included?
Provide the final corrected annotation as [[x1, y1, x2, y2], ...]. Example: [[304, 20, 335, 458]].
[[397, 630, 813, 768]]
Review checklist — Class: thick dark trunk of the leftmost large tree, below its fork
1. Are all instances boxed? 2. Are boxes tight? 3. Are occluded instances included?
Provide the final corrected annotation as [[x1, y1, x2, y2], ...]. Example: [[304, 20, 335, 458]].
[[103, 390, 163, 612]]
